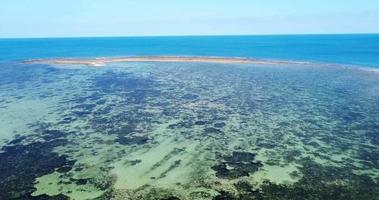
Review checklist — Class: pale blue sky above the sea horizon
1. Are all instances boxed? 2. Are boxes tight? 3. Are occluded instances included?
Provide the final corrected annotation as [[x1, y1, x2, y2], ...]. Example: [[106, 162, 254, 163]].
[[0, 0, 379, 38]]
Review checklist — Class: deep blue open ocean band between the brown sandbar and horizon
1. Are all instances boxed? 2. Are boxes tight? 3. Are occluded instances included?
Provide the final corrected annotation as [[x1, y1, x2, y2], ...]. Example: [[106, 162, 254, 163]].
[[0, 34, 379, 67]]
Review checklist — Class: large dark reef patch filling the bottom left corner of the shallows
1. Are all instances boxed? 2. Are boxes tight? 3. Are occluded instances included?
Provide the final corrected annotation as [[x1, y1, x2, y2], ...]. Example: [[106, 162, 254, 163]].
[[0, 134, 75, 200]]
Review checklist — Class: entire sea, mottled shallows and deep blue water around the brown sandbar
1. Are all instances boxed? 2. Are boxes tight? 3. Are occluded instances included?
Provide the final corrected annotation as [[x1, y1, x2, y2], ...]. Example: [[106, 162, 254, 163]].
[[0, 34, 379, 200]]
